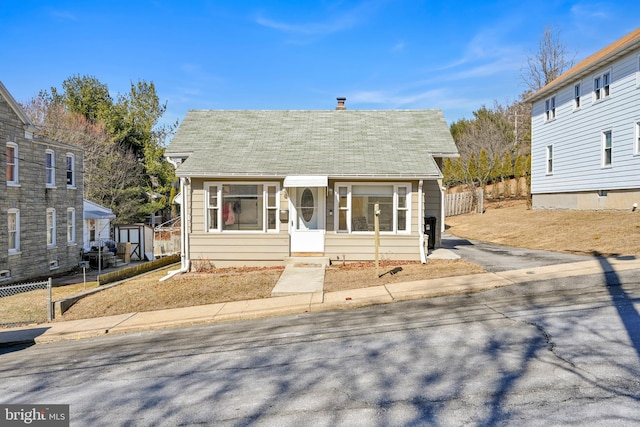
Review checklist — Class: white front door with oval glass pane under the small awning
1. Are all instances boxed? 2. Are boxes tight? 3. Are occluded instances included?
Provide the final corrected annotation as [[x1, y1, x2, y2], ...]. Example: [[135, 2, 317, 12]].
[[289, 187, 326, 253]]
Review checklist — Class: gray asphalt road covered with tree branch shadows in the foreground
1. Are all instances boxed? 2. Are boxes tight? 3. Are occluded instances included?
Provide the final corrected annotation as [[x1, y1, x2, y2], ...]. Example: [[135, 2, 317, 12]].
[[0, 270, 640, 426]]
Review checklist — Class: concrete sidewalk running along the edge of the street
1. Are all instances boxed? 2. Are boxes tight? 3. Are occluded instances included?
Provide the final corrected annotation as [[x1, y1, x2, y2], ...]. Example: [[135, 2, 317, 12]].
[[0, 257, 640, 347]]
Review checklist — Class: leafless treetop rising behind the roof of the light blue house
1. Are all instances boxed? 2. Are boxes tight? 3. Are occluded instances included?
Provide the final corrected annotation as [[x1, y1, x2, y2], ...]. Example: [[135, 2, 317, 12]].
[[521, 26, 575, 92]]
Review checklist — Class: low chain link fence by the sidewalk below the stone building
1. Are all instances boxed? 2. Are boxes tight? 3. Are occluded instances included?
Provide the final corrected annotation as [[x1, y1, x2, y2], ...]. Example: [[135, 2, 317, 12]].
[[0, 279, 53, 328]]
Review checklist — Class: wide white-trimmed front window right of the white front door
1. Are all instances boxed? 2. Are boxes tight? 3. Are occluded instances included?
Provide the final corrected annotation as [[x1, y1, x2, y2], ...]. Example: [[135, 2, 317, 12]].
[[334, 183, 411, 233]]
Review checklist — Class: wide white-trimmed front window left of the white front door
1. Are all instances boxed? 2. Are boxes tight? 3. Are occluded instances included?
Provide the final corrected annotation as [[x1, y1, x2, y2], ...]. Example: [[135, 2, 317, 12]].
[[205, 182, 280, 232]]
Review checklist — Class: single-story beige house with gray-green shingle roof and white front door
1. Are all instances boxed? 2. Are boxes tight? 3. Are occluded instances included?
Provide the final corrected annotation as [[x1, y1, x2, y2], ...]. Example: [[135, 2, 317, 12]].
[[165, 98, 458, 271]]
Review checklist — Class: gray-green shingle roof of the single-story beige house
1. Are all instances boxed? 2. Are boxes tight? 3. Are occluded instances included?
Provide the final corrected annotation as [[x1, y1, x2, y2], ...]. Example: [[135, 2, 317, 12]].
[[166, 110, 458, 178]]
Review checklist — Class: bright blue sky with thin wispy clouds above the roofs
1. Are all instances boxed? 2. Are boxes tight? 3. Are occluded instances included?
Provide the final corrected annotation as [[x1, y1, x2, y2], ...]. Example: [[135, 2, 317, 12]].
[[0, 0, 640, 130]]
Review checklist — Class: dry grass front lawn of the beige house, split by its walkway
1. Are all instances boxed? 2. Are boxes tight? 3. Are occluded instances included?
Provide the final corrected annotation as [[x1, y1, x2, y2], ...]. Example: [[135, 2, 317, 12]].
[[56, 260, 484, 321]]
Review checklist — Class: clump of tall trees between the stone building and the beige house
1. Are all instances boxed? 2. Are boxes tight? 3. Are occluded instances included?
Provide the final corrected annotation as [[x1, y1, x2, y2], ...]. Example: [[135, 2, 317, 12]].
[[26, 76, 177, 223]]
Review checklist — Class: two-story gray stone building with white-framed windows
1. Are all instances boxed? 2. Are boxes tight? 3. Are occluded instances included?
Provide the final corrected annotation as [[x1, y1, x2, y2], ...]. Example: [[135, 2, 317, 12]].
[[0, 82, 84, 285]]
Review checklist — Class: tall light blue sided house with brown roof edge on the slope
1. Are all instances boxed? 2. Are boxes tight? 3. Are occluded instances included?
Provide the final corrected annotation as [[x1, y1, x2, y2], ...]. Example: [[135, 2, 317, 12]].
[[529, 28, 640, 209]]
